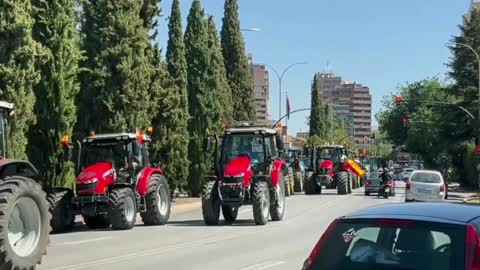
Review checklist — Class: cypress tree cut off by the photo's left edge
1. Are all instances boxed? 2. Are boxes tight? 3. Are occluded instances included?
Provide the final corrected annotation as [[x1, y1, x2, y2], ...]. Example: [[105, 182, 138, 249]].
[[0, 0, 44, 159]]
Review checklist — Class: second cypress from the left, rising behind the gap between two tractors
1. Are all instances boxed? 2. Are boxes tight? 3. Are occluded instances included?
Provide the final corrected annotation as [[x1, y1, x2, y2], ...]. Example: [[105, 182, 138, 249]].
[[29, 0, 82, 186]]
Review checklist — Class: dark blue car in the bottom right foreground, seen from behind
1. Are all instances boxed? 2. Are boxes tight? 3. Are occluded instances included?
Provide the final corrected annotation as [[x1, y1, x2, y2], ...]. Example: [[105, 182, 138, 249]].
[[302, 203, 480, 270]]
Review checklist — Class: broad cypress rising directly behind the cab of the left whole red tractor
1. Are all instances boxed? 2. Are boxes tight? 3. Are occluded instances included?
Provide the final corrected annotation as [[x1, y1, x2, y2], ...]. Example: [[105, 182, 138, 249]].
[[79, 0, 154, 133]]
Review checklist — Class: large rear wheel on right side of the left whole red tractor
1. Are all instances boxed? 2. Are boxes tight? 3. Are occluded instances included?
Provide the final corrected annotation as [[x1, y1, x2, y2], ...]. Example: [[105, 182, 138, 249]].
[[140, 174, 172, 226]]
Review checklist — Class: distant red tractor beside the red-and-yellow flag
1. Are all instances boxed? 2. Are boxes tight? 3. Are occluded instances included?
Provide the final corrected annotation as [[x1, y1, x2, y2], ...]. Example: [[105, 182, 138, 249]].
[[305, 145, 354, 195]]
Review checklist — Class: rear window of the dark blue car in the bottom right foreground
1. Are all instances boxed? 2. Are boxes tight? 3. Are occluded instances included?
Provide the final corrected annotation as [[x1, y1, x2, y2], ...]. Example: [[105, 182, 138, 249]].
[[311, 220, 465, 270]]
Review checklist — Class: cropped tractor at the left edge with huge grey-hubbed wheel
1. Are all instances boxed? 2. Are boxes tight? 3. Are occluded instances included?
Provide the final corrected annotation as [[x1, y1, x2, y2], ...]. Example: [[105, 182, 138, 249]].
[[0, 101, 51, 269]]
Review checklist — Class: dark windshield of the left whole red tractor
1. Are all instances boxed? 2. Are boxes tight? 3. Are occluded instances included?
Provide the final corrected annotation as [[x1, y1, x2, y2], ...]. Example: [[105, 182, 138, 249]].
[[81, 141, 128, 169]]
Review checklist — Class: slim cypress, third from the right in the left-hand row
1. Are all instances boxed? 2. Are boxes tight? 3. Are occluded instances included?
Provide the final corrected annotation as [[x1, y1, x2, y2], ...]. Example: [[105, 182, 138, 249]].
[[185, 0, 218, 195]]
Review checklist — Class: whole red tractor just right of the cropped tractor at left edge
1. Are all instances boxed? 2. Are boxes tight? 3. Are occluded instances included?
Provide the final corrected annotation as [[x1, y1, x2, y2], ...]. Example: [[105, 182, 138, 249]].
[[52, 133, 171, 231]]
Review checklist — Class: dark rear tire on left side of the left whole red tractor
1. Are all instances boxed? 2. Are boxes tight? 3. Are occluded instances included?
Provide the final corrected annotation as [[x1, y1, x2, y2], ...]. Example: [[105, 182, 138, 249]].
[[47, 189, 75, 233]]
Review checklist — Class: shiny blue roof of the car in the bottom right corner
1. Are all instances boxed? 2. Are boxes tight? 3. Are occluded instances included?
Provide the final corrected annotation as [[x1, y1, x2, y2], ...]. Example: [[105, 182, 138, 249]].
[[344, 203, 480, 223]]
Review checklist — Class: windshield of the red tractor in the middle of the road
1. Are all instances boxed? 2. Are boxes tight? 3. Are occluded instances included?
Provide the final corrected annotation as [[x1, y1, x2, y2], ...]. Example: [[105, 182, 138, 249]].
[[222, 134, 265, 166]]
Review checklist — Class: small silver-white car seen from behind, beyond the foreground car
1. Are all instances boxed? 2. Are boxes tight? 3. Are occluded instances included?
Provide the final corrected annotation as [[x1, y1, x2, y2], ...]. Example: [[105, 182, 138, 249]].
[[405, 170, 447, 202]]
